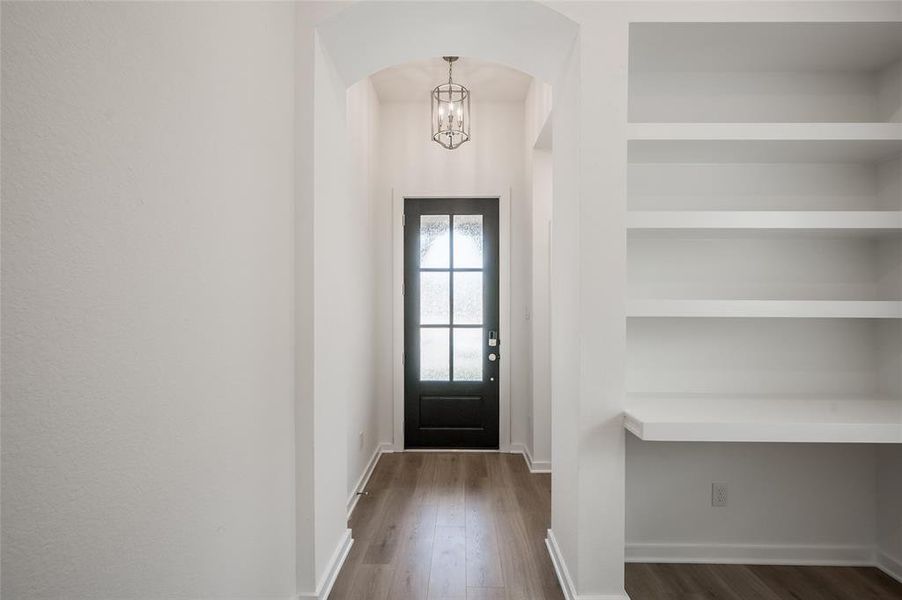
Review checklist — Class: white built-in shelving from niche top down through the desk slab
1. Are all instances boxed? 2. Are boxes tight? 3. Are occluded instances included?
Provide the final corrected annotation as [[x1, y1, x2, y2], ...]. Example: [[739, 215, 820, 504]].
[[624, 23, 902, 443]]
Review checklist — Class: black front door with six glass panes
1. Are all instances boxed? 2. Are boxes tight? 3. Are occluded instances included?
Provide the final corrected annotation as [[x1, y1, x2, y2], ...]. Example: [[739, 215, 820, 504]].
[[404, 198, 501, 448]]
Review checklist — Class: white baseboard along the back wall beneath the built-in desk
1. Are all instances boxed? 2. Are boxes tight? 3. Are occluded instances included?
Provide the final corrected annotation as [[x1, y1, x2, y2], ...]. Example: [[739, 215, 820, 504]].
[[626, 543, 874, 567]]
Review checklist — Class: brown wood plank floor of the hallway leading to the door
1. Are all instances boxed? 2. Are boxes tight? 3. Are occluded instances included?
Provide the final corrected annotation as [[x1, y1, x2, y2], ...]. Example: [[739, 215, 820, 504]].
[[329, 452, 563, 600]]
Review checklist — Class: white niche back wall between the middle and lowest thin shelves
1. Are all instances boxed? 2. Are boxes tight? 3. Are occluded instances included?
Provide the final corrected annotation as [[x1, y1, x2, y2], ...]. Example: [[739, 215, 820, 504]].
[[628, 232, 902, 300]]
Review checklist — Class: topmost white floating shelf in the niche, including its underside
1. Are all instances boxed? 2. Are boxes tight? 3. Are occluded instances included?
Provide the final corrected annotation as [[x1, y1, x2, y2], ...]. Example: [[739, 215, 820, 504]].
[[628, 123, 902, 163]]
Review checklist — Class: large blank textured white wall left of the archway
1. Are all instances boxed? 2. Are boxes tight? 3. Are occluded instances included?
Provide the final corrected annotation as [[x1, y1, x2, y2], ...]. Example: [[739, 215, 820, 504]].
[[2, 2, 294, 599]]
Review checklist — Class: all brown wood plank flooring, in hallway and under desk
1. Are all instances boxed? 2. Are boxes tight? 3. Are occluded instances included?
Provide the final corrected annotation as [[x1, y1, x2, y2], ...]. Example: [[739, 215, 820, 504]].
[[329, 452, 902, 600]]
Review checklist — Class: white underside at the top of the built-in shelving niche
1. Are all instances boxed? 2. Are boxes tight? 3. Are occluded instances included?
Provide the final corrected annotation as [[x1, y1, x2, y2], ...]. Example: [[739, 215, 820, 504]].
[[630, 23, 902, 71]]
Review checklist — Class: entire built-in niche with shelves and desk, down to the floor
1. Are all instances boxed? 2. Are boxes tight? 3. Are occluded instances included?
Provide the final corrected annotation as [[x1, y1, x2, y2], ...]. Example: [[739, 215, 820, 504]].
[[623, 19, 902, 580]]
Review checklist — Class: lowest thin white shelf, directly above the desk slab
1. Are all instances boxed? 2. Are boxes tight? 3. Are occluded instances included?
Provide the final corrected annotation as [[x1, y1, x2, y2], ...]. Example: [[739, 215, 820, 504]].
[[627, 300, 902, 319]]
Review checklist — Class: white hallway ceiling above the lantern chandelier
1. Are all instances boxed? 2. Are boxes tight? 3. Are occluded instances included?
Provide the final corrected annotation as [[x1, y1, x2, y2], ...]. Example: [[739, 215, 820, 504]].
[[370, 57, 532, 102]]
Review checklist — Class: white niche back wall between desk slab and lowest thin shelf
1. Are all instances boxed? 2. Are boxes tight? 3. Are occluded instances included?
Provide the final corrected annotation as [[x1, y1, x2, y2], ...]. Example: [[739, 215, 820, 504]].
[[627, 319, 885, 398]]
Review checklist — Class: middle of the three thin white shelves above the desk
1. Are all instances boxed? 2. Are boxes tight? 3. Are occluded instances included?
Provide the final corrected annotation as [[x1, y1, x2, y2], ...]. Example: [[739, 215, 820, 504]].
[[627, 210, 902, 232]]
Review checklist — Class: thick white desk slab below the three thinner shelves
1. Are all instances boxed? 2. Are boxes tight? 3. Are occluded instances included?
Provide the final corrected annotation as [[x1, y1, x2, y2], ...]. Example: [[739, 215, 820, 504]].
[[624, 396, 902, 444]]
